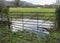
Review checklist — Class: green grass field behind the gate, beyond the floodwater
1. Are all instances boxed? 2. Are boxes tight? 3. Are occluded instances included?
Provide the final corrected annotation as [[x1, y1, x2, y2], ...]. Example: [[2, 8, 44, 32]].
[[10, 8, 55, 21]]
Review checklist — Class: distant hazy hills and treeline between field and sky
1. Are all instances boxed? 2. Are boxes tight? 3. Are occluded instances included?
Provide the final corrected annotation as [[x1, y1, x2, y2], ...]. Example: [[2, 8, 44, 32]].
[[2, 1, 56, 8]]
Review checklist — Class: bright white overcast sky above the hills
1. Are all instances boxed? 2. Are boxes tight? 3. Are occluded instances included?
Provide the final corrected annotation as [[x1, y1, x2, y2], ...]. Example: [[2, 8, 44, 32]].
[[6, 0, 56, 5]]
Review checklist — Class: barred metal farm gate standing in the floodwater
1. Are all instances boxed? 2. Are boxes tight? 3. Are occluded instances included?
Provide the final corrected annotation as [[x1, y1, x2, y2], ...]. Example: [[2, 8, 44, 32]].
[[10, 12, 56, 41]]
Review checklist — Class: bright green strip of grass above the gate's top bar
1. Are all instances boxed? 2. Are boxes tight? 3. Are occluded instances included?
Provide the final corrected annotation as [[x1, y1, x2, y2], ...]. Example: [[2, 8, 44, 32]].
[[10, 8, 55, 13]]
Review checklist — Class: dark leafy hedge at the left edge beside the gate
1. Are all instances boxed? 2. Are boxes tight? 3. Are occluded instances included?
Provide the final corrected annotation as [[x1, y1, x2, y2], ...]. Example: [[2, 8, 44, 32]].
[[0, 0, 11, 29]]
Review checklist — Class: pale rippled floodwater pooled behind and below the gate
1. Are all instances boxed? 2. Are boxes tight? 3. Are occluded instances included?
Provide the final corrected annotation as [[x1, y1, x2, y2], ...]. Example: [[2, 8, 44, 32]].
[[11, 19, 54, 39]]
